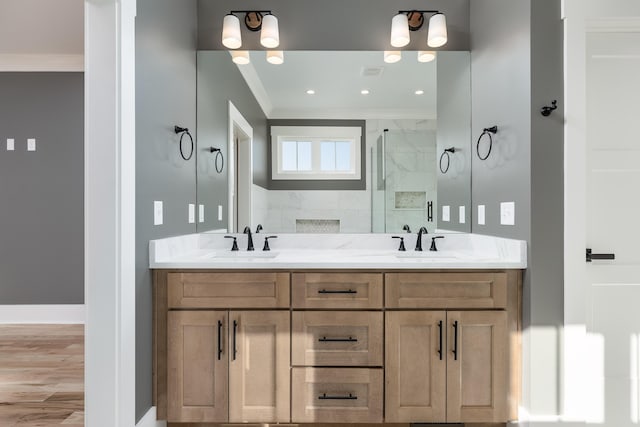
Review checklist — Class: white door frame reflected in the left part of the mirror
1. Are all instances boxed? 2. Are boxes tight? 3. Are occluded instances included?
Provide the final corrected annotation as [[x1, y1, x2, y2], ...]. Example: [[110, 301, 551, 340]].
[[227, 101, 253, 233]]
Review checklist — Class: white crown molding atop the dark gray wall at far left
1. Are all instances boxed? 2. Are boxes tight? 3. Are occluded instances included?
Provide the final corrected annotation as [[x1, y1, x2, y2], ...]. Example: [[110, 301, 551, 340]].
[[0, 53, 84, 72]]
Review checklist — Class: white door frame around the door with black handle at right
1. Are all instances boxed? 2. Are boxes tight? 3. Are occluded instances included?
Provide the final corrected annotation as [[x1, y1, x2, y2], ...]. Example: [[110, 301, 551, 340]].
[[561, 0, 640, 423]]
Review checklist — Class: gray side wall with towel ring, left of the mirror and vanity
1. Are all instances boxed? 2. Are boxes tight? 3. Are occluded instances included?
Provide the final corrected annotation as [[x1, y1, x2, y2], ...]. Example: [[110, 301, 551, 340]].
[[136, 0, 197, 419]]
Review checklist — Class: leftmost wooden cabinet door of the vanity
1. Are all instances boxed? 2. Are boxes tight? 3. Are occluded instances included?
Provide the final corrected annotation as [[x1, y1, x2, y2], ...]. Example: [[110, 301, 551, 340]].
[[167, 311, 229, 422]]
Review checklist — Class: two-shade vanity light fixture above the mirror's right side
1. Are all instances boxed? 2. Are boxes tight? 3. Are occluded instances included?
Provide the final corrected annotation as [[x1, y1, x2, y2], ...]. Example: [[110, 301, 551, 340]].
[[391, 10, 447, 47]]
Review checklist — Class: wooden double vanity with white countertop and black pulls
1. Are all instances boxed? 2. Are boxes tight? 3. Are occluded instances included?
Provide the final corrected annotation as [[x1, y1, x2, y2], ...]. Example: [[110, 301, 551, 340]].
[[150, 233, 526, 425]]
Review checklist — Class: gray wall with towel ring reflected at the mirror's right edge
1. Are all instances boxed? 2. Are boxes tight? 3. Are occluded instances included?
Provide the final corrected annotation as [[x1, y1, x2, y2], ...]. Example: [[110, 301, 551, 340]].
[[434, 54, 474, 232]]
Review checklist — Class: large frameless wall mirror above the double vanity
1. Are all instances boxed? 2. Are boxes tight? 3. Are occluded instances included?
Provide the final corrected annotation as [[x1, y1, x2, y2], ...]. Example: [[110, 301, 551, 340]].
[[197, 51, 472, 237]]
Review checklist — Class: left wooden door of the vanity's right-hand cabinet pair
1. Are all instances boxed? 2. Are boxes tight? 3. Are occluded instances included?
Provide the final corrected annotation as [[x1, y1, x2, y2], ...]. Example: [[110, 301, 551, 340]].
[[385, 311, 446, 423]]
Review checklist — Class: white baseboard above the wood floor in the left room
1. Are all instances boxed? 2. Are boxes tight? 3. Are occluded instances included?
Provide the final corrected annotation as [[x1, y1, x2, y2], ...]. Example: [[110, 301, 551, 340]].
[[0, 304, 85, 324]]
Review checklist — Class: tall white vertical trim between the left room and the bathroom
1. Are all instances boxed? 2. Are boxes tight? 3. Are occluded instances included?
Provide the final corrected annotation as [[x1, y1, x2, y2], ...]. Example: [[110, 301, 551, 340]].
[[84, 0, 136, 427]]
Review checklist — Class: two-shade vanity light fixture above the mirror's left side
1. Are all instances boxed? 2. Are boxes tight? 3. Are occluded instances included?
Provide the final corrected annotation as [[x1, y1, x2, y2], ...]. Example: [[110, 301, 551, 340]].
[[222, 10, 280, 49]]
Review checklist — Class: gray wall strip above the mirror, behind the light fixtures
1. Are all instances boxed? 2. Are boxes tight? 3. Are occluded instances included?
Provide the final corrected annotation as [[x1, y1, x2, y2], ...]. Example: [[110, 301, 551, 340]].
[[198, 0, 469, 50]]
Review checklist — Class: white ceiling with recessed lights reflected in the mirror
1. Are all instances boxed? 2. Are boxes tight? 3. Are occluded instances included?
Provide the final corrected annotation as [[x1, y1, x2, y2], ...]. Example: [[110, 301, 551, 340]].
[[236, 51, 436, 119]]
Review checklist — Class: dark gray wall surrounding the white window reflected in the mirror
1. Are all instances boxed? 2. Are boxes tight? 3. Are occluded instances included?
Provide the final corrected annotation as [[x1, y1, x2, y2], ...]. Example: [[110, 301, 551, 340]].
[[265, 119, 368, 190]]
